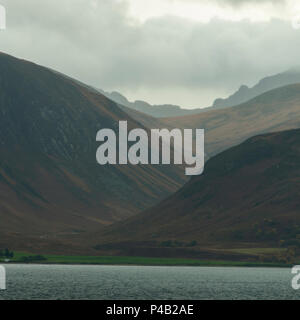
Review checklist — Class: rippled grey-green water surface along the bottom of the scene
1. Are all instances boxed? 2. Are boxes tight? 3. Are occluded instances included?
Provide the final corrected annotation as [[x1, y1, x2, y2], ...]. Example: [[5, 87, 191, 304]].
[[0, 264, 300, 300]]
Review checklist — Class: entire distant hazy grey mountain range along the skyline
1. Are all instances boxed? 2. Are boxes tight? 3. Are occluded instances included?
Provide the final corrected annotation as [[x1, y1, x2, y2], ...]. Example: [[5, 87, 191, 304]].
[[99, 67, 300, 118]]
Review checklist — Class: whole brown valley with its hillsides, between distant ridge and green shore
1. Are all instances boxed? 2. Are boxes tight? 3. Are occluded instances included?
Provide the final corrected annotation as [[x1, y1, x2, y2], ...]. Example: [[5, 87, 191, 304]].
[[0, 54, 300, 263]]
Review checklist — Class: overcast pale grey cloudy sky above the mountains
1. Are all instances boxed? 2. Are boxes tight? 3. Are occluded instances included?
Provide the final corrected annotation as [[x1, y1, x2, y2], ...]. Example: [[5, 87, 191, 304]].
[[0, 0, 300, 108]]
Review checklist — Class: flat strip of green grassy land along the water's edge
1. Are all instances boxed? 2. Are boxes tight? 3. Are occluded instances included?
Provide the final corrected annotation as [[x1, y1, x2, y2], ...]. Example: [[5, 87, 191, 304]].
[[0, 252, 290, 267]]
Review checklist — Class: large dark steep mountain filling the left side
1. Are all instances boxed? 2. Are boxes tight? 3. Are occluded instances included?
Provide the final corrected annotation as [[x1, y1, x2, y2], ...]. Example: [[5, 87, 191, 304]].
[[0, 53, 186, 246]]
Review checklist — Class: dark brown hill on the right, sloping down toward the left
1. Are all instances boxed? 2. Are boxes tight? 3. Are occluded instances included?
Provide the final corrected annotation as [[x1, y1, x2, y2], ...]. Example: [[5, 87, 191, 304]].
[[94, 130, 300, 259]]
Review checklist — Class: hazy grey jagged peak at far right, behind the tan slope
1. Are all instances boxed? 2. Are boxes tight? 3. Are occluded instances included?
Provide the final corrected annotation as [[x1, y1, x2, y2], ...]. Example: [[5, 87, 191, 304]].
[[212, 67, 300, 109]]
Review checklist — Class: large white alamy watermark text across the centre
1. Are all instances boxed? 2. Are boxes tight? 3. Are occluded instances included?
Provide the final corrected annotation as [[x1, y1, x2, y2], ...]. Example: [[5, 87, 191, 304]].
[[96, 121, 205, 176]]
